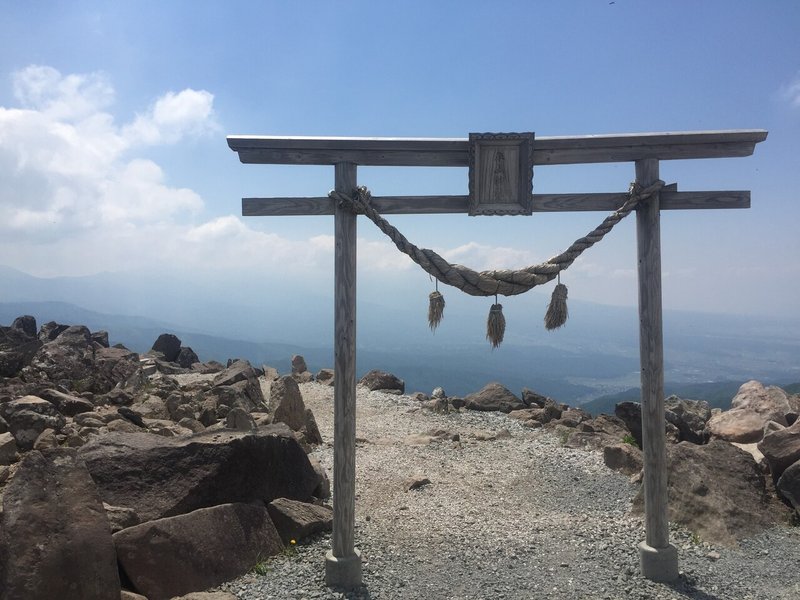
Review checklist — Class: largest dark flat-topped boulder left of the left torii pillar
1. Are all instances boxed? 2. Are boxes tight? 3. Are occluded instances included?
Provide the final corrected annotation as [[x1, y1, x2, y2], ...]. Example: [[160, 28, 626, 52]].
[[80, 423, 319, 521]]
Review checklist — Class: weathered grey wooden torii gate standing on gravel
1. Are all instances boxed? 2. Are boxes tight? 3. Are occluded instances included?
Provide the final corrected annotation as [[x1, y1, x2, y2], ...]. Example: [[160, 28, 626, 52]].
[[227, 130, 767, 588]]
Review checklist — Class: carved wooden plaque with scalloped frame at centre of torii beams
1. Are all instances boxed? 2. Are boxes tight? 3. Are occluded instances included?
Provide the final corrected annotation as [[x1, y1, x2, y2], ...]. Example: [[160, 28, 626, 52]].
[[469, 133, 534, 216]]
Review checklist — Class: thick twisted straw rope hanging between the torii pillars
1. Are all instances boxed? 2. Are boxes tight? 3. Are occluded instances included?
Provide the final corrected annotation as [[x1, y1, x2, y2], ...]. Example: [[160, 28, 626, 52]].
[[328, 180, 664, 296]]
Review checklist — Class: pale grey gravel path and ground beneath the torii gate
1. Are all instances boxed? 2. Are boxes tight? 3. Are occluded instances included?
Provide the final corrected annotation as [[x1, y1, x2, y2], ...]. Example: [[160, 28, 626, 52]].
[[220, 383, 800, 600]]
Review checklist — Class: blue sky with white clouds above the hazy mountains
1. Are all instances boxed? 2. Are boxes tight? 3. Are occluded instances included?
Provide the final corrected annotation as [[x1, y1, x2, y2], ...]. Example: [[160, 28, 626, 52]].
[[0, 0, 800, 316]]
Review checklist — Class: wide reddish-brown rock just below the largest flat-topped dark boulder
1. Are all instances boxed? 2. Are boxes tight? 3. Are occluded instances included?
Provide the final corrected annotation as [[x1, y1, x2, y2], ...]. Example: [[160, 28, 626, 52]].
[[113, 503, 283, 600]]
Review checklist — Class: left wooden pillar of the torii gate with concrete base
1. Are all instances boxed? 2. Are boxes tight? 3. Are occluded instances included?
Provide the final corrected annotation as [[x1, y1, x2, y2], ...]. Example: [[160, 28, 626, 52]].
[[325, 162, 361, 589]]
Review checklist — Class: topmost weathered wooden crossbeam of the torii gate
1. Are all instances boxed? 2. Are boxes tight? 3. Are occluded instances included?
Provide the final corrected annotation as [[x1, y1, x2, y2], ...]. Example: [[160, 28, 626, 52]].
[[227, 129, 767, 167]]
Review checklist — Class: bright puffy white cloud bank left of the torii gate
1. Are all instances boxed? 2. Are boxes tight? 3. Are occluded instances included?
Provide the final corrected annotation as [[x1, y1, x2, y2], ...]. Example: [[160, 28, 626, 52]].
[[0, 66, 217, 243]]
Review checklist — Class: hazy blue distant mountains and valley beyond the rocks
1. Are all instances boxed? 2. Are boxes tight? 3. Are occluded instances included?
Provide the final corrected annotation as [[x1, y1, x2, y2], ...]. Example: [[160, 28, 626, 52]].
[[0, 266, 800, 404]]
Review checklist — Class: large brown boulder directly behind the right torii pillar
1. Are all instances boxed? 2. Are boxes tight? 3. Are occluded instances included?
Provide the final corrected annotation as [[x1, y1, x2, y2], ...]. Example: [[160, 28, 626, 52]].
[[634, 439, 777, 545]]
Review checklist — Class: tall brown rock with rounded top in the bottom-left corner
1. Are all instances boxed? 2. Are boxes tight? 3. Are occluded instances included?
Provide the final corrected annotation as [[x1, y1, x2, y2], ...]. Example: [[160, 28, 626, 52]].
[[0, 448, 120, 600]]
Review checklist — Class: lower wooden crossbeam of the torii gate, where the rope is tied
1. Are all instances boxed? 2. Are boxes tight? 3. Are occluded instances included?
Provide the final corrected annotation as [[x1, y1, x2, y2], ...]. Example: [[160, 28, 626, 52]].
[[242, 190, 750, 217]]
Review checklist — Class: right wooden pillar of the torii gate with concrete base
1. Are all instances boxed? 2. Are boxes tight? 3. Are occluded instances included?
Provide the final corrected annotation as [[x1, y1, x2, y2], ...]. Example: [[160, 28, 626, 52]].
[[636, 158, 678, 582]]
